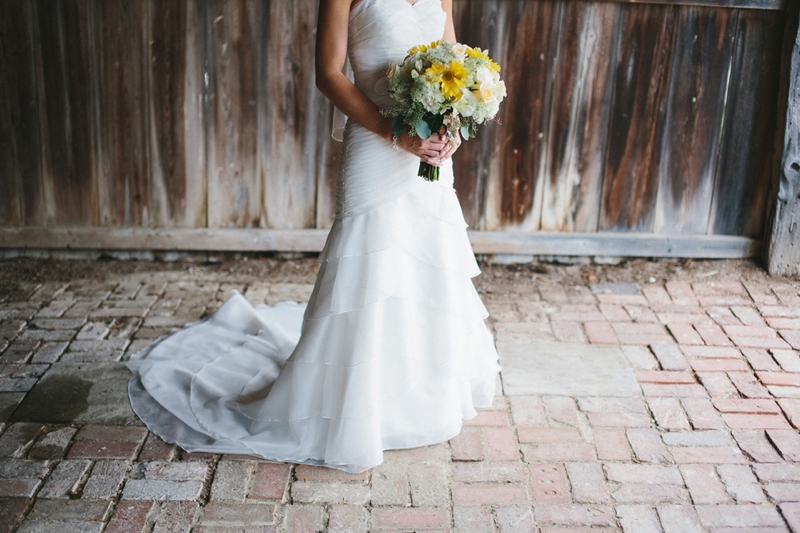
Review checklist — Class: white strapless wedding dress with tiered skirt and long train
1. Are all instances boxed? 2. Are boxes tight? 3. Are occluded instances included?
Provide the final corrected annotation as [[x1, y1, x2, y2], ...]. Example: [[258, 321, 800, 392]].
[[128, 0, 499, 472]]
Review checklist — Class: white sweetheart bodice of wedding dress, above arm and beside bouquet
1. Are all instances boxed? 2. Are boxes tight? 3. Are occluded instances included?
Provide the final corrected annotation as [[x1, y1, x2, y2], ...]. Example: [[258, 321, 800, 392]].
[[347, 0, 447, 107]]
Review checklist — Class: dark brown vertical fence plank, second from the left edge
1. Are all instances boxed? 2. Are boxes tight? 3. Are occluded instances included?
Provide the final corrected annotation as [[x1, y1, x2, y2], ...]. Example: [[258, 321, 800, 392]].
[[35, 0, 94, 224]]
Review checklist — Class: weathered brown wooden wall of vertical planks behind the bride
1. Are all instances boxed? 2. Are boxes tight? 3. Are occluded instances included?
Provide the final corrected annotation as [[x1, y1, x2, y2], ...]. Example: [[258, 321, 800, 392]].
[[0, 0, 785, 245]]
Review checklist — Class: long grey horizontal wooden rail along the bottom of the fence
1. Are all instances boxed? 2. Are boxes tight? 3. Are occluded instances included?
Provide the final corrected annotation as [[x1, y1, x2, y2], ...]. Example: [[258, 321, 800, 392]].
[[0, 227, 761, 259]]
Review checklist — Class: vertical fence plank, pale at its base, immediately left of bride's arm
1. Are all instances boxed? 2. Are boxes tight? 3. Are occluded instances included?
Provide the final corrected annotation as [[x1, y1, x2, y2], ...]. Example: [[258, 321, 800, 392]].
[[259, 0, 322, 228]]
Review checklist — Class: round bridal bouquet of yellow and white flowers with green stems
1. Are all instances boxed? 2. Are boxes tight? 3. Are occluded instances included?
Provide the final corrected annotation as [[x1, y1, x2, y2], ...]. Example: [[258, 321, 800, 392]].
[[381, 41, 506, 181]]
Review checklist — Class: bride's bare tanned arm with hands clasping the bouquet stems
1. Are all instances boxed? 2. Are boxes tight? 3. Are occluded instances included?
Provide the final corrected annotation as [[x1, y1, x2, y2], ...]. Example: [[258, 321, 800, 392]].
[[315, 0, 449, 165]]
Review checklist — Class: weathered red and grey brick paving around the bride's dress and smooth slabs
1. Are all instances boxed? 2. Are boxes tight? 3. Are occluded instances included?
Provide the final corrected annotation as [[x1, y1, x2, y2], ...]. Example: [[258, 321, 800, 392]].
[[0, 264, 800, 533]]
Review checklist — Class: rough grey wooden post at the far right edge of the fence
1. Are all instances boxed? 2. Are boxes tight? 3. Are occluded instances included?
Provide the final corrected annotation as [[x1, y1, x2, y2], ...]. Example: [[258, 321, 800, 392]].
[[766, 6, 800, 276]]
